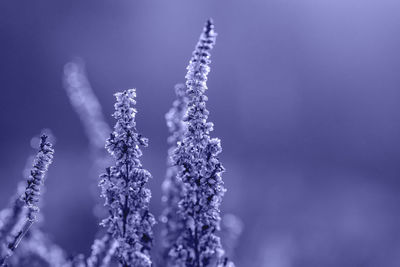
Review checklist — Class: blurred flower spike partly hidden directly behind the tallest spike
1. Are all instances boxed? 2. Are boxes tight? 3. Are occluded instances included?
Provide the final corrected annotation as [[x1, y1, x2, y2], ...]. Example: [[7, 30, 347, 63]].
[[161, 84, 187, 261]]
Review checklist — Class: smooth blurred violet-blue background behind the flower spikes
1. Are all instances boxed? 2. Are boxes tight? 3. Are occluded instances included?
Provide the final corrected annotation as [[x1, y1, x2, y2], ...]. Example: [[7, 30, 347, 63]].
[[0, 0, 400, 267]]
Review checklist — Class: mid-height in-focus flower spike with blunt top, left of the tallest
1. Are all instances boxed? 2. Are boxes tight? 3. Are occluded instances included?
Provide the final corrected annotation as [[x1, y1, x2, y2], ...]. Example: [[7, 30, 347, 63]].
[[100, 89, 155, 267]]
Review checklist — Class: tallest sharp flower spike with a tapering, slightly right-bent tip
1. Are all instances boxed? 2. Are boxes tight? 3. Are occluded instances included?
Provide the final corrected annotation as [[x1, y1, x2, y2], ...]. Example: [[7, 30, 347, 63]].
[[169, 20, 233, 267]]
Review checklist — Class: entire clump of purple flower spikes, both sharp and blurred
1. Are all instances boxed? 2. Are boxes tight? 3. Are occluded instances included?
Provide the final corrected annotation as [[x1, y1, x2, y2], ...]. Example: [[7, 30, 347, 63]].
[[0, 17, 241, 267]]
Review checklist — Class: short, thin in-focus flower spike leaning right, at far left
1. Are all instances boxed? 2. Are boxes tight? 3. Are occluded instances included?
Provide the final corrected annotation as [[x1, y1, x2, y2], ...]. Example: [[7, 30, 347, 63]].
[[0, 135, 54, 266]]
